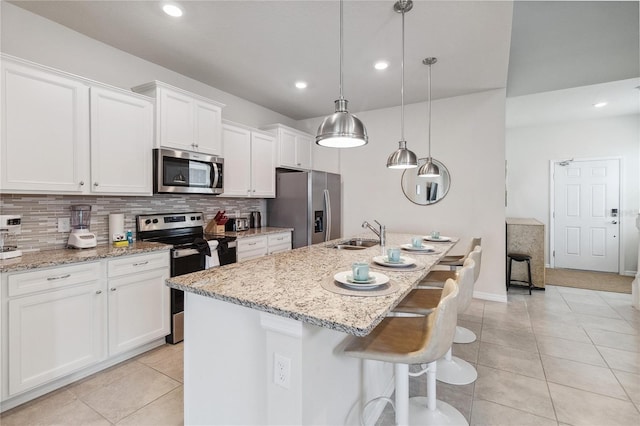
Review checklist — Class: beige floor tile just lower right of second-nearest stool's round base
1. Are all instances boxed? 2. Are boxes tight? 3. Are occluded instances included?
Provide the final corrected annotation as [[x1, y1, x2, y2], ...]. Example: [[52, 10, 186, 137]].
[[474, 365, 556, 420]]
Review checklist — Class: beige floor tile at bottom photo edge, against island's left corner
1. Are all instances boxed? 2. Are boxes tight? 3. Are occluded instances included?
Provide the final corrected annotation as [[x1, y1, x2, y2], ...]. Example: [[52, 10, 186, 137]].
[[117, 386, 184, 426]]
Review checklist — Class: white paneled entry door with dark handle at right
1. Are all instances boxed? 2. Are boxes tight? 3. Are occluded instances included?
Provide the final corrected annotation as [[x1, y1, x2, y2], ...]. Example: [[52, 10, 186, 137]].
[[554, 159, 620, 272]]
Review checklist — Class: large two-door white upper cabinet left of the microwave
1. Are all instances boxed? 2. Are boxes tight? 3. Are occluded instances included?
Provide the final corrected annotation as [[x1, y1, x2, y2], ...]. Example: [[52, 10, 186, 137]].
[[0, 55, 153, 195]]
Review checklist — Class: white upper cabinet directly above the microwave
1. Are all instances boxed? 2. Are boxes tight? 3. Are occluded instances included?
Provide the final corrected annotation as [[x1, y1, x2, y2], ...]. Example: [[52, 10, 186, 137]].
[[132, 81, 224, 155]]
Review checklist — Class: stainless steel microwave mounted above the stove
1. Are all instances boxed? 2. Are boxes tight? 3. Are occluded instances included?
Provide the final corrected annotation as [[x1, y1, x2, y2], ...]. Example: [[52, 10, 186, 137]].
[[153, 148, 224, 195]]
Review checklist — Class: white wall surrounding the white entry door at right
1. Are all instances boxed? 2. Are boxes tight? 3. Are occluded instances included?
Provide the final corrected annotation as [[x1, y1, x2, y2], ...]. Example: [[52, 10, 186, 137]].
[[506, 115, 640, 275]]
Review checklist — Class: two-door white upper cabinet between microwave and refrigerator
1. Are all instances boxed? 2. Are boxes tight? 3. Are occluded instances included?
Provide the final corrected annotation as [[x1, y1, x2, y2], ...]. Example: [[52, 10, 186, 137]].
[[222, 122, 276, 198]]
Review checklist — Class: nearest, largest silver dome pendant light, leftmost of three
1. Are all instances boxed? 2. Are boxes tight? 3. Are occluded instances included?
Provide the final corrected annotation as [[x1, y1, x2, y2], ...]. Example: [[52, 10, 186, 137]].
[[316, 0, 369, 148]]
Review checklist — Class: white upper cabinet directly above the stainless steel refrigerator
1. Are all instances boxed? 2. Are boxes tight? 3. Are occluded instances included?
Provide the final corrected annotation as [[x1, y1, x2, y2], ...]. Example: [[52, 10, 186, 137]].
[[263, 124, 314, 170]]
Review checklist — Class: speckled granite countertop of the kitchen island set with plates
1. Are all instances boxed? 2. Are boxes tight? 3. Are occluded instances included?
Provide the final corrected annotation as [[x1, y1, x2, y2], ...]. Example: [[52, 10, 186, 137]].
[[167, 233, 457, 336]]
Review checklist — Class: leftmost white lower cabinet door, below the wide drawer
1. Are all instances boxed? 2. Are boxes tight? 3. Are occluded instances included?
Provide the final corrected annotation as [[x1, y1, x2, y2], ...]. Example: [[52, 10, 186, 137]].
[[8, 280, 106, 395]]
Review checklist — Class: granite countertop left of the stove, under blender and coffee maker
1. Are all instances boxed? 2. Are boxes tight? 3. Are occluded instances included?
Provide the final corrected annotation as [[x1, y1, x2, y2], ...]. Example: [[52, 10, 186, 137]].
[[0, 242, 171, 272]]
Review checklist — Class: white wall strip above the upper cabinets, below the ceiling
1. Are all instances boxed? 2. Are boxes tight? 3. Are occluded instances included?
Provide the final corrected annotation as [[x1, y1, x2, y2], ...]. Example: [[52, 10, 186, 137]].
[[0, 1, 295, 127]]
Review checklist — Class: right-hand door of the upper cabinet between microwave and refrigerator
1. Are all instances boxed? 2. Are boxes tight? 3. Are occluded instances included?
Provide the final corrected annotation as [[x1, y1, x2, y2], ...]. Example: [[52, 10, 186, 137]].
[[251, 133, 276, 198]]
